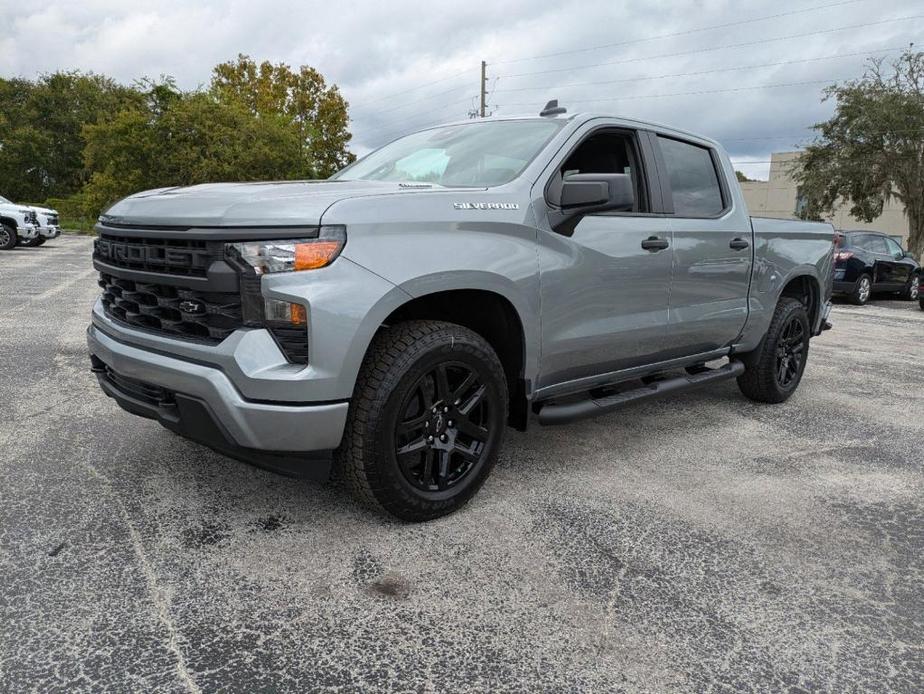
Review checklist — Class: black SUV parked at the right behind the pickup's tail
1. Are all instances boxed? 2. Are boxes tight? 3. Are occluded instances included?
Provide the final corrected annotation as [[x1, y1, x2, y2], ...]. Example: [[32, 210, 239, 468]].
[[834, 230, 921, 306]]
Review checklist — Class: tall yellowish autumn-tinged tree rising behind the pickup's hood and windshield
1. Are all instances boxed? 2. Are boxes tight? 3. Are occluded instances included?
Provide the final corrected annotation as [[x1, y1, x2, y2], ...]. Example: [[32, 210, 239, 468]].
[[210, 55, 356, 178]]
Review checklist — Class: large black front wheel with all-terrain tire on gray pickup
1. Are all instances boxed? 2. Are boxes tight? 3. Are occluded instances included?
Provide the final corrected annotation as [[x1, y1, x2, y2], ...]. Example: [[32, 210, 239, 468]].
[[336, 321, 507, 522]]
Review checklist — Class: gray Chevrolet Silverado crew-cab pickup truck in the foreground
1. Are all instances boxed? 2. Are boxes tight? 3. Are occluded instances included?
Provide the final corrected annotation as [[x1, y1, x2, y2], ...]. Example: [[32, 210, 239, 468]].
[[88, 108, 834, 520]]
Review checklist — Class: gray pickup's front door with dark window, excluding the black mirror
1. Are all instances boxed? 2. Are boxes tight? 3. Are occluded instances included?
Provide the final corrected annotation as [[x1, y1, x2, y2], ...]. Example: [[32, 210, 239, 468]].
[[534, 126, 673, 388]]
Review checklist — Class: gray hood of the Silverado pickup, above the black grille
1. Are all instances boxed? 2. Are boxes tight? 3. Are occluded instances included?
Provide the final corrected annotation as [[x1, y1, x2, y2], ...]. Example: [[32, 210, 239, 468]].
[[101, 181, 470, 227]]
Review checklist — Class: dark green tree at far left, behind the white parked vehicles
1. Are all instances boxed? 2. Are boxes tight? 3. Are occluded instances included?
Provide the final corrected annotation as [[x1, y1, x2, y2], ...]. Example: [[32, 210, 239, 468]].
[[0, 72, 138, 201]]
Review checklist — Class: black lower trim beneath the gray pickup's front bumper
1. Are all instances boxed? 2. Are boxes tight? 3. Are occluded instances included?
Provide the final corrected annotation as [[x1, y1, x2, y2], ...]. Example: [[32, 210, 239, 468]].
[[93, 357, 333, 481]]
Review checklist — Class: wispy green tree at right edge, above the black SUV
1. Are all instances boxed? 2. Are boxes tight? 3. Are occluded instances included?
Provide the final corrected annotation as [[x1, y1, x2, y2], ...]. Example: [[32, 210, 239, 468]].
[[792, 49, 924, 257]]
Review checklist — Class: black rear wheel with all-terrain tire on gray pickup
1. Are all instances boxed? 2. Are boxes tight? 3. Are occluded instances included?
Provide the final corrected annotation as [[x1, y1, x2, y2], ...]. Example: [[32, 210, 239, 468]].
[[738, 296, 811, 403]]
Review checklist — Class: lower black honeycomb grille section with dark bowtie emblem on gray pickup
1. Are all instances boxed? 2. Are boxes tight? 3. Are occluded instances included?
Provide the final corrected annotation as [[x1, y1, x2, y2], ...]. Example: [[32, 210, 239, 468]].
[[99, 272, 243, 343]]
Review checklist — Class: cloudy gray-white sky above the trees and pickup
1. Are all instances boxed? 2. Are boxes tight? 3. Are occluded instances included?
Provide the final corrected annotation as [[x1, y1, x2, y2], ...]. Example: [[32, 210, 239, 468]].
[[0, 0, 924, 177]]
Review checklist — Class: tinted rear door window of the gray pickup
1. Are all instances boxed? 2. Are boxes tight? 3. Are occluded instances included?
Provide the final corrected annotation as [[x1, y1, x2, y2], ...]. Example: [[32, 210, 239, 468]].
[[658, 136, 725, 217]]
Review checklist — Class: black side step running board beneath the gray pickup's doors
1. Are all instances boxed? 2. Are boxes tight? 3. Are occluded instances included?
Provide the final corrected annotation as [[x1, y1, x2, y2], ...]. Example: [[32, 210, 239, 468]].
[[539, 361, 744, 425]]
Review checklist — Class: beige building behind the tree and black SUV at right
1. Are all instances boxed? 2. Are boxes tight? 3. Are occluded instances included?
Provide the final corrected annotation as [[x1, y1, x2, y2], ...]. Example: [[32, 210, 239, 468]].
[[741, 152, 908, 248]]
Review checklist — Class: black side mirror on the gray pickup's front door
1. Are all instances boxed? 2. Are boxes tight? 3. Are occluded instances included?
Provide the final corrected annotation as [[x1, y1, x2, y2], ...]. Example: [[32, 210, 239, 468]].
[[550, 174, 635, 236]]
